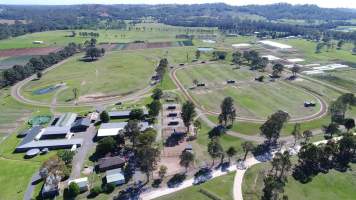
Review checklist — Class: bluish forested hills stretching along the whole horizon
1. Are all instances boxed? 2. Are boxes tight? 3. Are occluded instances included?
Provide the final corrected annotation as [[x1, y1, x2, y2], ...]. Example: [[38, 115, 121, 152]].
[[0, 3, 356, 21]]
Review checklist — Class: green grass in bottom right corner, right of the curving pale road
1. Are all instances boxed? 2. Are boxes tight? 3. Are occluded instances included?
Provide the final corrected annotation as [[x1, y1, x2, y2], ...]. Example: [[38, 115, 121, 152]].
[[242, 164, 356, 200]]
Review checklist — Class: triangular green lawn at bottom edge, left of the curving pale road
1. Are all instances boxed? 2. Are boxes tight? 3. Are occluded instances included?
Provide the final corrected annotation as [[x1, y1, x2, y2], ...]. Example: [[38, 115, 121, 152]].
[[155, 172, 235, 200]]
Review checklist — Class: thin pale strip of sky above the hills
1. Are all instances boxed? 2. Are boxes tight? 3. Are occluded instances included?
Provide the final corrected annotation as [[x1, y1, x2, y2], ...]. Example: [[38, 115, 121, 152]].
[[0, 0, 356, 8]]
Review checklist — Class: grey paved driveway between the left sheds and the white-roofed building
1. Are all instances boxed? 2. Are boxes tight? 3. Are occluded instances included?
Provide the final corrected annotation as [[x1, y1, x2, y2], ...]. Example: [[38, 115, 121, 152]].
[[70, 125, 96, 179]]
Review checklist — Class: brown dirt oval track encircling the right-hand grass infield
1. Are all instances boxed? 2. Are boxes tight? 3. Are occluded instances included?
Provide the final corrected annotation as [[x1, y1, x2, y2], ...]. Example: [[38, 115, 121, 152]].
[[170, 62, 328, 123]]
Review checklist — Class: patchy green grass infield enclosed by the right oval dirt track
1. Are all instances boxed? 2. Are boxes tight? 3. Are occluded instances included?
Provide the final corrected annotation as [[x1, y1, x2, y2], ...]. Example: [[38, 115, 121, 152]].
[[177, 65, 320, 119]]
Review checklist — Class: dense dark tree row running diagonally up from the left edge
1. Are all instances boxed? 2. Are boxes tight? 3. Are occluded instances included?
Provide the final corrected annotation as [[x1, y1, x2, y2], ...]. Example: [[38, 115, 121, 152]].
[[0, 43, 82, 88]]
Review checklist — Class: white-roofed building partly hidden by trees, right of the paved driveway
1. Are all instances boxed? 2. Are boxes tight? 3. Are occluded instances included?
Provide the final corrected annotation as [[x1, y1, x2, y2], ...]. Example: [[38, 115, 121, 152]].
[[97, 122, 151, 137]]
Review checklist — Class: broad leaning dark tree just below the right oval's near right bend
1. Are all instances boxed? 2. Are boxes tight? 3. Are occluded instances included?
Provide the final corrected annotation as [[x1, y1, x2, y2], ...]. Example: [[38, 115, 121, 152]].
[[260, 111, 289, 144]]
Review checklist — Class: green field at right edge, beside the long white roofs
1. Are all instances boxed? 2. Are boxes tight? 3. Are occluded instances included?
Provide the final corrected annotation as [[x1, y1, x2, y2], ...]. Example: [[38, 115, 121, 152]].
[[277, 39, 356, 63]]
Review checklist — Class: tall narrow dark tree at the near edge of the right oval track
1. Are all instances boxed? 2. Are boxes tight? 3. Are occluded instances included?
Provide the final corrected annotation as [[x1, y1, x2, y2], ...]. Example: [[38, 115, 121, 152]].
[[219, 97, 236, 126]]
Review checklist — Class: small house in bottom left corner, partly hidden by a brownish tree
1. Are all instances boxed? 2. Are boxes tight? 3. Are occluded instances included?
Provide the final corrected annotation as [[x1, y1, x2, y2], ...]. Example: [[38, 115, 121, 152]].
[[41, 174, 61, 199]]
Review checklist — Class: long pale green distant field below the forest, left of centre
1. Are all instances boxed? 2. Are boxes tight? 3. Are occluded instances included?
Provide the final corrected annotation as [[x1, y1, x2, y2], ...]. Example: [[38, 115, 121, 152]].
[[0, 23, 217, 49]]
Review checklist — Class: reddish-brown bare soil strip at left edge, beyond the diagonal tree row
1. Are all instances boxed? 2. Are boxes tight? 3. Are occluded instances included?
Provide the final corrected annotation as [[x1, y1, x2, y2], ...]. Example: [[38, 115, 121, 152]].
[[0, 47, 61, 57]]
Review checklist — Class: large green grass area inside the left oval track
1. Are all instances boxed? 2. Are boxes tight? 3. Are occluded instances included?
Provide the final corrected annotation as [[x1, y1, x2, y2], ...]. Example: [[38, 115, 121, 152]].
[[22, 50, 157, 103]]
